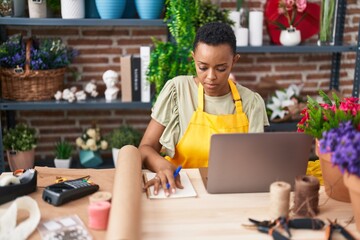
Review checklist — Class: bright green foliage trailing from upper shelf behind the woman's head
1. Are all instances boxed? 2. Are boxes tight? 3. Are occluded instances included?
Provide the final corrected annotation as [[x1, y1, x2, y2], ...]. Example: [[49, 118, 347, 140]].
[[146, 0, 233, 97]]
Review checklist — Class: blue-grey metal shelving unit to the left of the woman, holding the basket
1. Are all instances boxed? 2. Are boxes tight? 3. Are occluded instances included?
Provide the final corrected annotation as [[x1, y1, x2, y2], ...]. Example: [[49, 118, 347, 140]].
[[0, 17, 166, 173]]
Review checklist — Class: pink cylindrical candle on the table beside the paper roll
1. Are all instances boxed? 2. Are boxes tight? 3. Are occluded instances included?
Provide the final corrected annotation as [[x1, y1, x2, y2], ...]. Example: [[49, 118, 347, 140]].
[[88, 201, 111, 230]]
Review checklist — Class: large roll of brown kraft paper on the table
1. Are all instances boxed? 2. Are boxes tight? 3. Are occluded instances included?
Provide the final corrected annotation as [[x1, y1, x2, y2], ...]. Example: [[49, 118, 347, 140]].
[[106, 145, 142, 240]]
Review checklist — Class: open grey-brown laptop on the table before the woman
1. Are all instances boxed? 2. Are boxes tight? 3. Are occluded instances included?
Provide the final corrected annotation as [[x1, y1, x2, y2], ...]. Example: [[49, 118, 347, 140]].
[[200, 132, 313, 193]]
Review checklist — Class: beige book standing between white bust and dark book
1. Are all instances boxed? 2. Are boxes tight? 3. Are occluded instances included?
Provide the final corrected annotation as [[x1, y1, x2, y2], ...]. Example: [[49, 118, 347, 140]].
[[120, 55, 132, 102]]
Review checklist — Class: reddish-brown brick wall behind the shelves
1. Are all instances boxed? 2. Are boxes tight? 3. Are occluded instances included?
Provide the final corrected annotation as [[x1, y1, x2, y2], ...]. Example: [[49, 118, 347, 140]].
[[4, 0, 360, 161]]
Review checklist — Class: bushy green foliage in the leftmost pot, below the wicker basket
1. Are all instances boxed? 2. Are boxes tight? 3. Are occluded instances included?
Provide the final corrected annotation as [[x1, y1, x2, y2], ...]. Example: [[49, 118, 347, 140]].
[[3, 123, 37, 151]]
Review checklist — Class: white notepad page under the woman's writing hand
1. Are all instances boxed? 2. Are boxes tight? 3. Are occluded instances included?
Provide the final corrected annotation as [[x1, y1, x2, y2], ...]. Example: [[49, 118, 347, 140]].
[[144, 171, 197, 199]]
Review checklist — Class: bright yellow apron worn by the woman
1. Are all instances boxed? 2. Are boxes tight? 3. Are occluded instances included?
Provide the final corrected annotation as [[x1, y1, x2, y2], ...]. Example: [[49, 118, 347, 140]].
[[166, 80, 249, 168]]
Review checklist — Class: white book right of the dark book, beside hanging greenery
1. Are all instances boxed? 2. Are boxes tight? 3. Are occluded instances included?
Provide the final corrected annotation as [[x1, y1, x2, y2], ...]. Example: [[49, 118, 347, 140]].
[[140, 46, 151, 102]]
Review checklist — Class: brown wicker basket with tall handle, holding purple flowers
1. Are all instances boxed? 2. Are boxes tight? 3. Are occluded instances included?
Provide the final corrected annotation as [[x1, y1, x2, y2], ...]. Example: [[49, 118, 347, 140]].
[[0, 39, 66, 101]]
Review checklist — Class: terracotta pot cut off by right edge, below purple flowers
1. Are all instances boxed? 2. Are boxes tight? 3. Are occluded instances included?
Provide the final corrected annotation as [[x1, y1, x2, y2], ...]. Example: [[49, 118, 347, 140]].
[[343, 173, 360, 231]]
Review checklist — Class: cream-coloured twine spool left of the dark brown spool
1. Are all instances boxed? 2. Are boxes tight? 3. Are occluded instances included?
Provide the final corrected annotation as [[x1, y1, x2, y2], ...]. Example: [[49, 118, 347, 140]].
[[270, 181, 291, 219]]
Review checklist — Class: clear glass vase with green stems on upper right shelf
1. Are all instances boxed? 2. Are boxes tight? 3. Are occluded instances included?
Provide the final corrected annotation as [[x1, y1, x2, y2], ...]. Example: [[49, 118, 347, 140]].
[[317, 0, 338, 46]]
